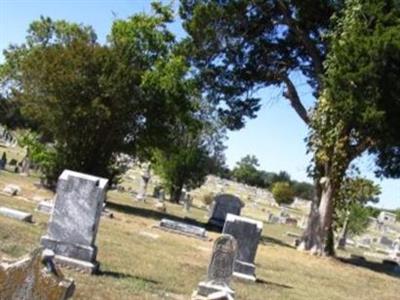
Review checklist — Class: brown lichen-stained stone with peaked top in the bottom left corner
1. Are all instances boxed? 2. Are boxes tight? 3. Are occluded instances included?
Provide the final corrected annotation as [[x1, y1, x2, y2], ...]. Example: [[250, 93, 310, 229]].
[[0, 249, 75, 300]]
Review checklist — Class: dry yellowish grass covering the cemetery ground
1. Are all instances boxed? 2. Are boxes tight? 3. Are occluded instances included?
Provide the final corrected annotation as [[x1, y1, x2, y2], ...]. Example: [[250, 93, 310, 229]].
[[0, 172, 400, 300]]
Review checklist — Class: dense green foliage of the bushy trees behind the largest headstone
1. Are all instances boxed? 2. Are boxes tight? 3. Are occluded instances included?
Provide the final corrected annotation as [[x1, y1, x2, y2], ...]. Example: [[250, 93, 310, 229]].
[[0, 4, 192, 181]]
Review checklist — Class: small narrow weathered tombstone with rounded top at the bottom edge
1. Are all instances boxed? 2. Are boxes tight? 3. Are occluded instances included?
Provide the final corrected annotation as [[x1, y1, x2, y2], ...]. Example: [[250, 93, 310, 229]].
[[192, 234, 237, 299]]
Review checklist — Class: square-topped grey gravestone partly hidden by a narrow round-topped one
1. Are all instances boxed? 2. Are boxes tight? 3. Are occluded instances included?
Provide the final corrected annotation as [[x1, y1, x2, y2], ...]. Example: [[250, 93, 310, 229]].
[[222, 214, 263, 281]]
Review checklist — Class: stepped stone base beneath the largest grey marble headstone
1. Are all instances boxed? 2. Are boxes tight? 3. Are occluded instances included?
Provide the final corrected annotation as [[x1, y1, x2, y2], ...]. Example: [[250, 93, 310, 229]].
[[40, 236, 97, 263]]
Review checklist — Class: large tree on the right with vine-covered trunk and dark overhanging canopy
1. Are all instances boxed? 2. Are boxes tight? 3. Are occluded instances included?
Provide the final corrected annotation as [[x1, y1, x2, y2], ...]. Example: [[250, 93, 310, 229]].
[[180, 0, 400, 254]]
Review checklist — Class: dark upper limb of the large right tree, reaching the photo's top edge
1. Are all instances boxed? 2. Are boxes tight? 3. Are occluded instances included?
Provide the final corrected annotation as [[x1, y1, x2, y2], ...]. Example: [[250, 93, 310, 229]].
[[278, 0, 324, 79]]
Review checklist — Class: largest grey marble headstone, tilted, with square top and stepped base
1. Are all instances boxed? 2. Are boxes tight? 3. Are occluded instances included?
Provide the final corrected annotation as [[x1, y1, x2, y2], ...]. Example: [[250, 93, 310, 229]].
[[41, 170, 108, 273]]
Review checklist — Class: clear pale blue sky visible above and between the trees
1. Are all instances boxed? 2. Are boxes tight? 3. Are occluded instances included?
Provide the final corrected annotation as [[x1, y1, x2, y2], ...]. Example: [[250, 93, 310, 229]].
[[0, 0, 400, 209]]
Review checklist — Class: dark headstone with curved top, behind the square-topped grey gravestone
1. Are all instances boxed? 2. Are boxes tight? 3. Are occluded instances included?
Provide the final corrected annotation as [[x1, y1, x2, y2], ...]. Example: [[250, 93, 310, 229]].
[[208, 194, 244, 228]]
